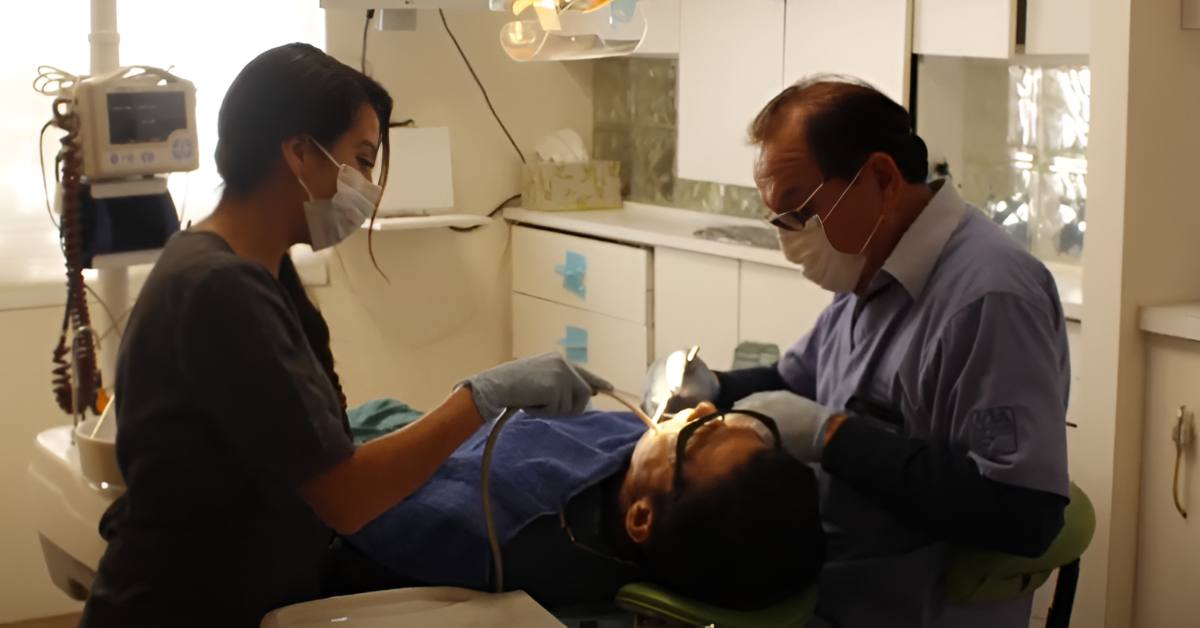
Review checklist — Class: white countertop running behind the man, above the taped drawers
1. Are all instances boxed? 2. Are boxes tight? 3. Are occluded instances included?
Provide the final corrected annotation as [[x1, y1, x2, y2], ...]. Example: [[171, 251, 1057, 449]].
[[504, 203, 1084, 321]]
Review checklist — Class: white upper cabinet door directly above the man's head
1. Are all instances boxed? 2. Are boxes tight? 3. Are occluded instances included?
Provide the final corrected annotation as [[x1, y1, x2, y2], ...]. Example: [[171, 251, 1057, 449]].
[[784, 0, 912, 107]]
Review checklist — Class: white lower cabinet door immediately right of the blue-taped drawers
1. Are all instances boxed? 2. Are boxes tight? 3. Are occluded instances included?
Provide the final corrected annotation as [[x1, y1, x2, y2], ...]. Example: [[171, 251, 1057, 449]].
[[654, 249, 738, 370]]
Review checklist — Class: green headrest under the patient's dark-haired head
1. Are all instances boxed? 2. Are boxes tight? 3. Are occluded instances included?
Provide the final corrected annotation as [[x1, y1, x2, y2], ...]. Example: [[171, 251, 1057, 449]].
[[617, 582, 817, 628]]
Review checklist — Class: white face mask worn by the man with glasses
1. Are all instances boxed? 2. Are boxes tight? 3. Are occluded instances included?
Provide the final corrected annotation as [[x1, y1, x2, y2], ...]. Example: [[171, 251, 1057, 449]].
[[775, 166, 883, 293]]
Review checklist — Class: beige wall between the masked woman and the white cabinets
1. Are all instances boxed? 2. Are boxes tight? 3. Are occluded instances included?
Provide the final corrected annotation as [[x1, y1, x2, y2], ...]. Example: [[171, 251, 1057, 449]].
[[314, 11, 592, 408]]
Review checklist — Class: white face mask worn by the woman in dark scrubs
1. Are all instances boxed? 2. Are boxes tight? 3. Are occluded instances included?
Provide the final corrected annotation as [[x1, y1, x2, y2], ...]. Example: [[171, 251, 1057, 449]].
[[296, 139, 383, 251]]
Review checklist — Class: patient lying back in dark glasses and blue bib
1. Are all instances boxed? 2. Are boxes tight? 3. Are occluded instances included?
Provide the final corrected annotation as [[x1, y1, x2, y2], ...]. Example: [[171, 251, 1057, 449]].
[[343, 403, 824, 608]]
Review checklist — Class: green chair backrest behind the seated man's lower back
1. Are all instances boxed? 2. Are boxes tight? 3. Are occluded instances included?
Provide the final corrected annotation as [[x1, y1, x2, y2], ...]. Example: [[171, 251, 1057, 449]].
[[946, 483, 1096, 602]]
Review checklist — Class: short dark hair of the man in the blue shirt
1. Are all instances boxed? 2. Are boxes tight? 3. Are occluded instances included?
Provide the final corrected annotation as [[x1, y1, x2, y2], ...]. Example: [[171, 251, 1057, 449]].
[[750, 76, 929, 183]]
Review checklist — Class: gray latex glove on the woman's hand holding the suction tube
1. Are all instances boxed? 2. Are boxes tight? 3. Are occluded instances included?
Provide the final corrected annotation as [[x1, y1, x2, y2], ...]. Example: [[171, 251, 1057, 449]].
[[458, 353, 612, 423]]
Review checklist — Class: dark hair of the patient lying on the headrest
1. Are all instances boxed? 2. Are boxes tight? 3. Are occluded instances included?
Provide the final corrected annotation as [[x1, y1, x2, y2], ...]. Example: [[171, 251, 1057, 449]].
[[641, 449, 826, 609]]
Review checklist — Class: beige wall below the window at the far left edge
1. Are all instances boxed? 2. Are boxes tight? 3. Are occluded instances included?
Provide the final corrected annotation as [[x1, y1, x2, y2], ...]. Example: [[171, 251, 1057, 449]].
[[0, 307, 79, 623]]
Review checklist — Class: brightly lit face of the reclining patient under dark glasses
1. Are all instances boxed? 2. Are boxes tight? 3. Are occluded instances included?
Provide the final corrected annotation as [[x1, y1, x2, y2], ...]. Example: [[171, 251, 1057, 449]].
[[622, 402, 768, 508]]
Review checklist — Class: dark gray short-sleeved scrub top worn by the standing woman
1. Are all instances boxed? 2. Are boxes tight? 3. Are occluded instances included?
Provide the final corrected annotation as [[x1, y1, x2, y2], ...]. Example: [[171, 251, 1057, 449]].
[[82, 231, 354, 628]]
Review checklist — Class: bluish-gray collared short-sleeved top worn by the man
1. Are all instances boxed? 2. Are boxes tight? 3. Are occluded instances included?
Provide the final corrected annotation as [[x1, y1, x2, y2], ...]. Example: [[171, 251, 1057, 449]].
[[779, 180, 1070, 628]]
